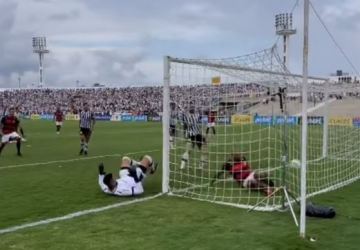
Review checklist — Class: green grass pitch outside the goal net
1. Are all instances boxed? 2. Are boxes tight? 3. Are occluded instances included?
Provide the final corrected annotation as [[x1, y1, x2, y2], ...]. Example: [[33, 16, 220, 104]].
[[0, 121, 360, 250]]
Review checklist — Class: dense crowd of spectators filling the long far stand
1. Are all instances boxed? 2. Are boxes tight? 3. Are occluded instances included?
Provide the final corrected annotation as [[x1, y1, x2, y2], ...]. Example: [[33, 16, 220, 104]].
[[0, 84, 267, 115]]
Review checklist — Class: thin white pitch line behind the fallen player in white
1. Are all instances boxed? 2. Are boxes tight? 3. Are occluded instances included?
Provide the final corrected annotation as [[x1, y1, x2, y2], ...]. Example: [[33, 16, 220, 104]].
[[0, 150, 160, 170]]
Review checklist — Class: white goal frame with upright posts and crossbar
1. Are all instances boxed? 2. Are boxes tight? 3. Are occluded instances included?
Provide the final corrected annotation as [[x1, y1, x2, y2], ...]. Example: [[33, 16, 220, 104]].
[[162, 52, 338, 235]]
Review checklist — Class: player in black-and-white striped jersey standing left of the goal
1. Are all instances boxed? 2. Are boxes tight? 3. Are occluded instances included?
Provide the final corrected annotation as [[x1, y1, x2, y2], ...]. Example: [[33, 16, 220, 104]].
[[79, 103, 95, 155]]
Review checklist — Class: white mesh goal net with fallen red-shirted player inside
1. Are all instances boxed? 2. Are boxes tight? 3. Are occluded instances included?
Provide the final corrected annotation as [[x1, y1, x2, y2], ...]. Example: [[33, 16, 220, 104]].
[[163, 47, 360, 210]]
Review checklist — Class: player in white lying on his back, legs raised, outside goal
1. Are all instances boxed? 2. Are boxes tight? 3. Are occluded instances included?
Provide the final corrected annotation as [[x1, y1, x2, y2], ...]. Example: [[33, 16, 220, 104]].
[[98, 155, 157, 196]]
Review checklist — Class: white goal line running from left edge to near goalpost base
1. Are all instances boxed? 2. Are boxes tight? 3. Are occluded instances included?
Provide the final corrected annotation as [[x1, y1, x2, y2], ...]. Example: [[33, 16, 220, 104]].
[[0, 193, 163, 235]]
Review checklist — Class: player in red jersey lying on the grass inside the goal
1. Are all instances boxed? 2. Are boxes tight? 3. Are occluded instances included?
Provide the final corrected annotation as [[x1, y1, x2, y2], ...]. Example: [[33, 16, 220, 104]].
[[211, 154, 274, 196]]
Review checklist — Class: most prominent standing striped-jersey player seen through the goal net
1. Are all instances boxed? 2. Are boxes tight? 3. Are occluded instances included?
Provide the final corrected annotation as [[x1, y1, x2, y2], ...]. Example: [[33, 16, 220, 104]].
[[180, 107, 207, 169]]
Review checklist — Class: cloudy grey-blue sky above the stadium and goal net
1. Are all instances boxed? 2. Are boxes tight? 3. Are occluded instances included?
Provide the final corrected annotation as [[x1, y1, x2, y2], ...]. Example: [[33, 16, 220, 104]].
[[0, 0, 360, 88]]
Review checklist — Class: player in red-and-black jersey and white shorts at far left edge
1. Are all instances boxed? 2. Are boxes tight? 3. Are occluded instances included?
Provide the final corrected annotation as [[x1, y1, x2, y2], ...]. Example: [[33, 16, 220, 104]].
[[0, 108, 21, 156]]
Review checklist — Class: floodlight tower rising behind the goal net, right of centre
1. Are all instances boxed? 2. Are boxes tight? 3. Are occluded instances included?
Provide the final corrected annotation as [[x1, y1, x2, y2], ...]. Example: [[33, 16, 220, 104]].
[[275, 13, 296, 69]]
